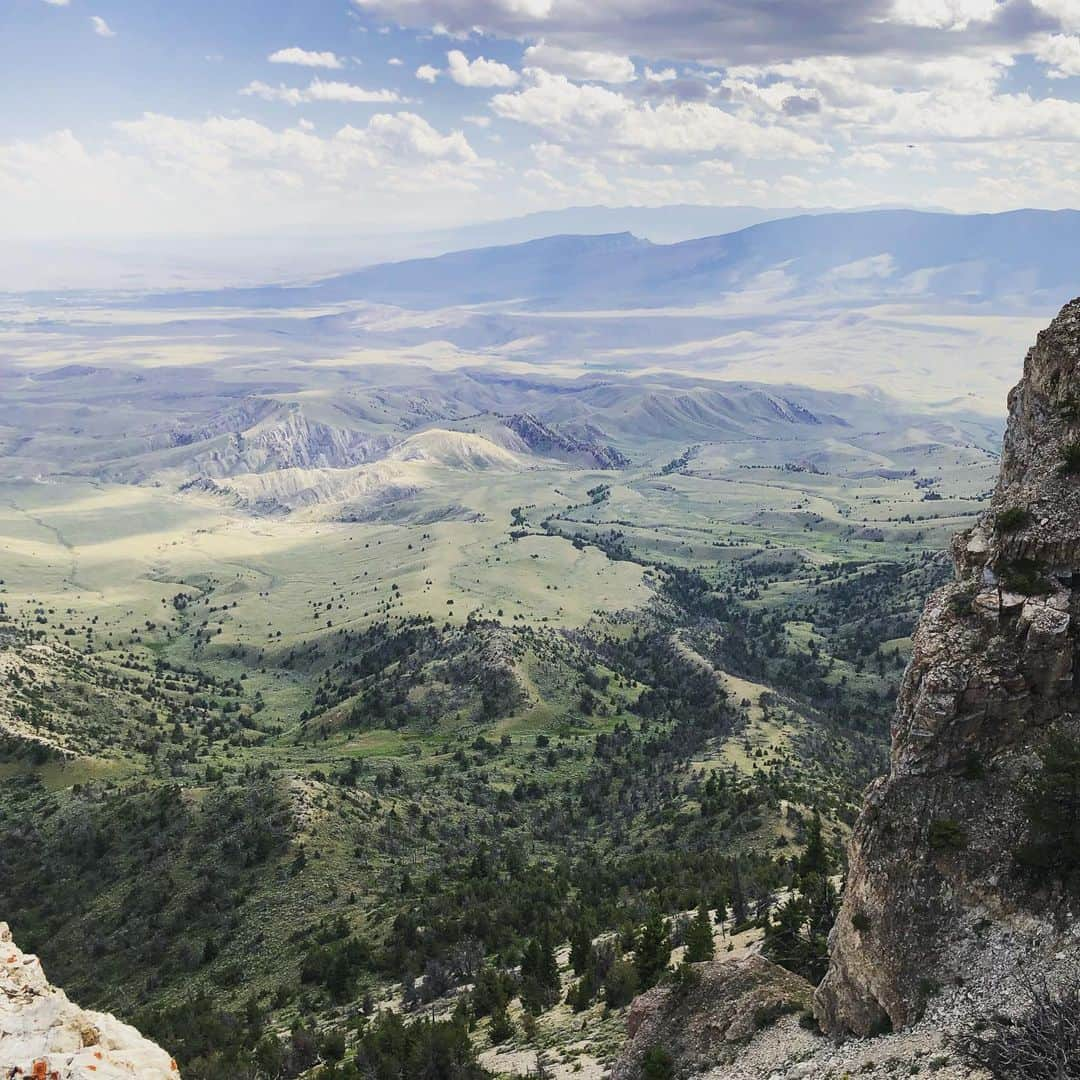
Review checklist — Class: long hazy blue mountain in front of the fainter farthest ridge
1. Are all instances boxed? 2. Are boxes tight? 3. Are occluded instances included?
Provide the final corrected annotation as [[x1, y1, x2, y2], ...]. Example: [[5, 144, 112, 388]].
[[152, 210, 1080, 313]]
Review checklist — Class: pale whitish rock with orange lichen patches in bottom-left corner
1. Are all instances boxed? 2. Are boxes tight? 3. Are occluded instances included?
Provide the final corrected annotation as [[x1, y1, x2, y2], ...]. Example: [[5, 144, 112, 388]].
[[0, 922, 180, 1080]]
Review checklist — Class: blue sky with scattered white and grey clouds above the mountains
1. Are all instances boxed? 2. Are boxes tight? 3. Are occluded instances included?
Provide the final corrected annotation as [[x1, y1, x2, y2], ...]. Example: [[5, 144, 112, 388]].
[[6, 0, 1080, 240]]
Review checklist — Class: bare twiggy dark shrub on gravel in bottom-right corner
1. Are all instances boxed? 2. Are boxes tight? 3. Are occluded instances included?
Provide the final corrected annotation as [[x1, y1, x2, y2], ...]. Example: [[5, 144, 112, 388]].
[[955, 974, 1080, 1080]]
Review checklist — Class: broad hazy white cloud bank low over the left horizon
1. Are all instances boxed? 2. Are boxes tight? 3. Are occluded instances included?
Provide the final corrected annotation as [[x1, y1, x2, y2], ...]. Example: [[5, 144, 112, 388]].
[[0, 111, 492, 234]]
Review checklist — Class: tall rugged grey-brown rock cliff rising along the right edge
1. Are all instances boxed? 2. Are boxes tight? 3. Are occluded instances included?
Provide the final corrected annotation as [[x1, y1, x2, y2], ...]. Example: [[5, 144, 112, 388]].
[[815, 300, 1080, 1035]]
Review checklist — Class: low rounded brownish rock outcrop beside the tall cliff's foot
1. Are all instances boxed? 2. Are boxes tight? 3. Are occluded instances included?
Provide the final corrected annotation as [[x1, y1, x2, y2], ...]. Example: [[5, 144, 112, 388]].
[[611, 955, 813, 1080]]
